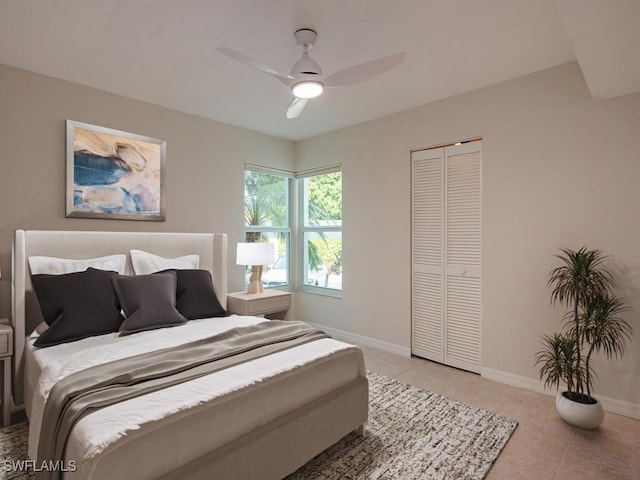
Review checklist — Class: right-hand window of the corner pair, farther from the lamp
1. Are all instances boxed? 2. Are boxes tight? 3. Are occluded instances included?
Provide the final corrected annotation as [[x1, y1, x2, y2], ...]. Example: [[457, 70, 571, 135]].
[[298, 171, 342, 294]]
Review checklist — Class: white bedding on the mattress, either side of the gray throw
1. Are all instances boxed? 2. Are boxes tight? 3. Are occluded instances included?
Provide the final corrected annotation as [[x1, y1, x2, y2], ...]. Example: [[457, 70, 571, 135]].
[[25, 316, 365, 478]]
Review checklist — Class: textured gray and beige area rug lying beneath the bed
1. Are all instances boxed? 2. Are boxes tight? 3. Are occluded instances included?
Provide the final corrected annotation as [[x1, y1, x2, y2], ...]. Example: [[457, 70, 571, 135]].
[[0, 373, 518, 480]]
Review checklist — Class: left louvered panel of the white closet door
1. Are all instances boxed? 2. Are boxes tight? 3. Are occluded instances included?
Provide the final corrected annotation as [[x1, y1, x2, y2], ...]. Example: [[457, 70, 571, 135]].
[[411, 148, 444, 363]]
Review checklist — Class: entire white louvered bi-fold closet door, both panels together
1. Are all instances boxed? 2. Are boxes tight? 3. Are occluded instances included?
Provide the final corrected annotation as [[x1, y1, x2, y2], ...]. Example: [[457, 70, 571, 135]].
[[411, 141, 482, 373]]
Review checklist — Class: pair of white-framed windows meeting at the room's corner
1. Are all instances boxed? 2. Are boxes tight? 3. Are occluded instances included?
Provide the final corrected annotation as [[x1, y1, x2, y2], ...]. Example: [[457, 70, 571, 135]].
[[244, 165, 342, 296]]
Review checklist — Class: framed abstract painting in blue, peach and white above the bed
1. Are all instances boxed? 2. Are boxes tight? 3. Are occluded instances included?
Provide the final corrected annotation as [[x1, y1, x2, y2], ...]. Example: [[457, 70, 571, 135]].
[[66, 120, 166, 222]]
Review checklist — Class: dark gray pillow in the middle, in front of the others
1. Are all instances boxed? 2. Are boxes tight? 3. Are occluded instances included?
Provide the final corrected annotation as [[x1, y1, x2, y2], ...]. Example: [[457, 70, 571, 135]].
[[112, 272, 187, 335]]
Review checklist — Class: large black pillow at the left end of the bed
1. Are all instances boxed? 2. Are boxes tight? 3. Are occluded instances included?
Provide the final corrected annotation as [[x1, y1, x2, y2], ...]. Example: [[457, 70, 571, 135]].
[[31, 268, 123, 347]]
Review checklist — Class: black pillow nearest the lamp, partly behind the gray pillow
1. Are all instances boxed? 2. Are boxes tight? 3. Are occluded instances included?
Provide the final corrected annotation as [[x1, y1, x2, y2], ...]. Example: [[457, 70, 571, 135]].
[[154, 270, 227, 320]]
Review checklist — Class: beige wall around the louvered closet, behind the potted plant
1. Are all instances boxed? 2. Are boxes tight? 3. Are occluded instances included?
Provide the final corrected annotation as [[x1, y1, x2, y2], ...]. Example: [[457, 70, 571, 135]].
[[296, 63, 640, 411]]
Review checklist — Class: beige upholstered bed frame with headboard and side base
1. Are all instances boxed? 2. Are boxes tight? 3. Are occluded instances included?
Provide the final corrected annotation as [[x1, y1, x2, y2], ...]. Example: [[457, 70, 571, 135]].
[[12, 230, 368, 479]]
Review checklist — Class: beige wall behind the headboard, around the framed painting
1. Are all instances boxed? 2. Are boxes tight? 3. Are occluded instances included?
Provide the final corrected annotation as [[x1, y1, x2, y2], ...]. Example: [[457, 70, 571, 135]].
[[0, 65, 295, 317]]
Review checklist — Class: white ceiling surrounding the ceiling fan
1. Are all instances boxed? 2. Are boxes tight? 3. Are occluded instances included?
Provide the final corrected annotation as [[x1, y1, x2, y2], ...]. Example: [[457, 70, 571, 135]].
[[0, 0, 640, 140]]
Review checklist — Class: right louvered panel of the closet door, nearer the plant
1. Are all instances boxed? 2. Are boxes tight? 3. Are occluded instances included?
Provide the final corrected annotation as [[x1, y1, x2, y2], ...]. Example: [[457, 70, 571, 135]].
[[444, 142, 480, 373]]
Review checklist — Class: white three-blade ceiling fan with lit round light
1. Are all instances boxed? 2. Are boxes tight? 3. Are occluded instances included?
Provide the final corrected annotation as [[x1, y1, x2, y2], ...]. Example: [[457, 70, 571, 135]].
[[216, 28, 404, 118]]
